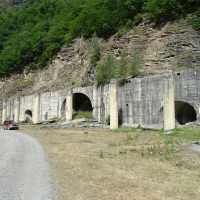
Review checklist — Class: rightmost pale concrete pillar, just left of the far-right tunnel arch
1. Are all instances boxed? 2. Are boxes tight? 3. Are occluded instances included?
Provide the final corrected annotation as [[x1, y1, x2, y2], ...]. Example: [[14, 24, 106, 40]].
[[164, 74, 176, 132]]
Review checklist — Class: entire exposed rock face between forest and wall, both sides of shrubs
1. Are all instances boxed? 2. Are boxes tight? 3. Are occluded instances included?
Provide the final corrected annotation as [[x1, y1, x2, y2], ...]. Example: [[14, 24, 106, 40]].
[[0, 20, 200, 96]]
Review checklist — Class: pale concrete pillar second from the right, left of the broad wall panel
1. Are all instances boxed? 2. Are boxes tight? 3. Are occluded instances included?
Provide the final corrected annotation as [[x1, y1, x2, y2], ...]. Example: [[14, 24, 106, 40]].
[[110, 80, 119, 129]]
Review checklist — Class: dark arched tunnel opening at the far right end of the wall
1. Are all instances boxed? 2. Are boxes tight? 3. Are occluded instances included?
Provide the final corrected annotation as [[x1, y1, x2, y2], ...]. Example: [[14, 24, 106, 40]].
[[175, 101, 197, 125]]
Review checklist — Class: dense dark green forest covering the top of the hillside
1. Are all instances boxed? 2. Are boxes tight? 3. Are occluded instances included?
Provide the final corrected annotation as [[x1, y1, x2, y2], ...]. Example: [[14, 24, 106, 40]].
[[0, 0, 200, 76]]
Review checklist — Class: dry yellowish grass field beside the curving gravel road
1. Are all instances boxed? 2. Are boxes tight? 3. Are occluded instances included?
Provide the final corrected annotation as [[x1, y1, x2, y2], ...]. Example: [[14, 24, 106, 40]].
[[20, 127, 200, 200]]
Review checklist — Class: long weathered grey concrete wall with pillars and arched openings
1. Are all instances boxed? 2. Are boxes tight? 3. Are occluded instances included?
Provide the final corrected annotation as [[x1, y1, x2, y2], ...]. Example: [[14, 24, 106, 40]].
[[1, 69, 200, 130]]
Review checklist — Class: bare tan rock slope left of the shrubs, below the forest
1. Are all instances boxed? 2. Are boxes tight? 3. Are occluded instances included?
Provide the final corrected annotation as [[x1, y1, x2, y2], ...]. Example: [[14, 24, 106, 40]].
[[0, 39, 92, 96]]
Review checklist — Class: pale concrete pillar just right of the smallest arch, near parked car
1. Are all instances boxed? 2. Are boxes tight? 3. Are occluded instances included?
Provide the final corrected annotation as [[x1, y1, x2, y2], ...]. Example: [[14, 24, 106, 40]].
[[32, 93, 40, 124]]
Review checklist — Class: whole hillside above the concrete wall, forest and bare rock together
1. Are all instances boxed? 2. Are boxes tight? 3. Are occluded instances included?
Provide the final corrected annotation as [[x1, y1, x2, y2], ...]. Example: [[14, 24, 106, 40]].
[[0, 0, 200, 96]]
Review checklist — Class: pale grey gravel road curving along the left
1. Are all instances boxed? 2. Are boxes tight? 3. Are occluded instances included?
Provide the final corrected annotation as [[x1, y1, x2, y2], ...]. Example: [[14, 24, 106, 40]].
[[0, 130, 55, 200]]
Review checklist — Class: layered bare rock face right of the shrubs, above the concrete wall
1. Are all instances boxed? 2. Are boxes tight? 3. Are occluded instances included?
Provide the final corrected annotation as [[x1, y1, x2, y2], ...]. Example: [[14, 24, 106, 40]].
[[105, 21, 200, 75]]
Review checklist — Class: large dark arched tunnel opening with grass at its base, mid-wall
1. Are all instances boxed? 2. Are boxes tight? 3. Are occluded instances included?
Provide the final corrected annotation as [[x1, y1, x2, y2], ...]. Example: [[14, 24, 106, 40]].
[[73, 93, 93, 118]]
